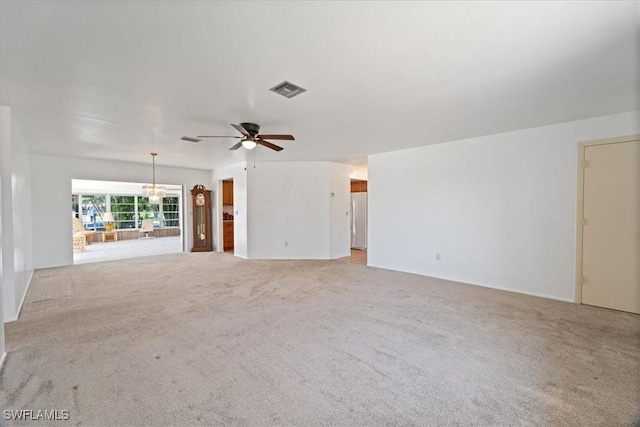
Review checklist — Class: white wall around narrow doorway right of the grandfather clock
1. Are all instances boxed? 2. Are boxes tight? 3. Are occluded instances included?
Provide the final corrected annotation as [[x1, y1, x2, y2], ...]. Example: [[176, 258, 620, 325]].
[[212, 162, 248, 258]]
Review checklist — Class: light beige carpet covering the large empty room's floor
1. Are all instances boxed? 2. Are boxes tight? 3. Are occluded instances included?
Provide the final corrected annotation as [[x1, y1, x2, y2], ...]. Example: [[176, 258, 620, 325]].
[[0, 253, 640, 426]]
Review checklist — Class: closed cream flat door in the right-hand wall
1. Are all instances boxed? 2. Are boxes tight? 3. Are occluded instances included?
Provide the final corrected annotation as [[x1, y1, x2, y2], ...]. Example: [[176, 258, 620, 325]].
[[582, 141, 640, 313]]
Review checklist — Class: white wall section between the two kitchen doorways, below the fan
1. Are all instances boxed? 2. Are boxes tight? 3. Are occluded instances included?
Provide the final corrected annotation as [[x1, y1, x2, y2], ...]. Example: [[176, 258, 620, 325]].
[[247, 162, 366, 259]]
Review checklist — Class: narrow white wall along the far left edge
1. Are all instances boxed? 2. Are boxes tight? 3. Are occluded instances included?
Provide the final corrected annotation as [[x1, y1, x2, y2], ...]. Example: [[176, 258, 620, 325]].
[[0, 107, 33, 321]]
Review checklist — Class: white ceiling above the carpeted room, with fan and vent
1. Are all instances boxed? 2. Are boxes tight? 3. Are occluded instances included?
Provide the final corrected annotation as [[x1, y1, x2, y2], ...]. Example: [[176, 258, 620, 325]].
[[0, 0, 640, 169]]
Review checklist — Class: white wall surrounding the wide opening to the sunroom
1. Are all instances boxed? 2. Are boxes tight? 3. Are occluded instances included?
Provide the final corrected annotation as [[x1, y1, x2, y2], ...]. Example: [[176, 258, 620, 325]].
[[30, 155, 211, 268]]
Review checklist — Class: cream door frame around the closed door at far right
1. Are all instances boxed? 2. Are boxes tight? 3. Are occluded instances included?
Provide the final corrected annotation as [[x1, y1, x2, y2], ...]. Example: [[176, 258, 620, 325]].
[[575, 134, 640, 304]]
